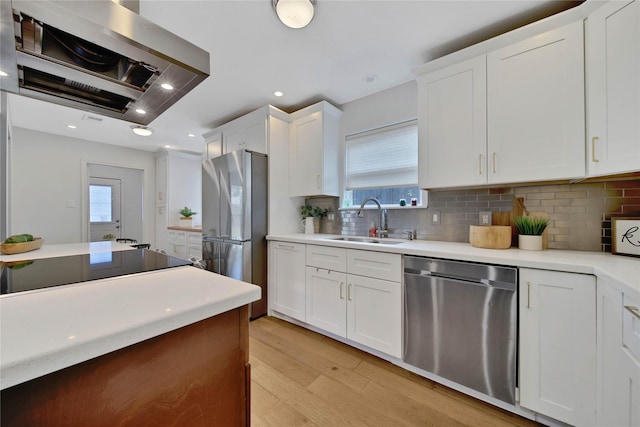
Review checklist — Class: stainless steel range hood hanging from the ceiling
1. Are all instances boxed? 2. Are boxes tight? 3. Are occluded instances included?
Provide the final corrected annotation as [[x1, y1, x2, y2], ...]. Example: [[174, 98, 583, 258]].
[[0, 0, 209, 125]]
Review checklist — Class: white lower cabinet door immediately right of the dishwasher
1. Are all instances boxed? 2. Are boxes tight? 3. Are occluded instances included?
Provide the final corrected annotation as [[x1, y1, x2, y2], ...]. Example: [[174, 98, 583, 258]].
[[519, 268, 596, 426]]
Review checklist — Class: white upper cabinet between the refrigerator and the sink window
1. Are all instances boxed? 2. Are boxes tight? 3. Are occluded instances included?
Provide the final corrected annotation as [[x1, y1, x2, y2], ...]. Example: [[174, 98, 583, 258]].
[[289, 101, 342, 197]]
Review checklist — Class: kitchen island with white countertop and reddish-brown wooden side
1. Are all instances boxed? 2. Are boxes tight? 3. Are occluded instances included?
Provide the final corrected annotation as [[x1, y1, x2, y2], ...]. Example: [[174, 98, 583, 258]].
[[0, 244, 260, 426]]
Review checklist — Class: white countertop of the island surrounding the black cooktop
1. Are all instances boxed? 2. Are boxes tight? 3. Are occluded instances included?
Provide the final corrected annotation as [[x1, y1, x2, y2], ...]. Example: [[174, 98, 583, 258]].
[[0, 244, 260, 389]]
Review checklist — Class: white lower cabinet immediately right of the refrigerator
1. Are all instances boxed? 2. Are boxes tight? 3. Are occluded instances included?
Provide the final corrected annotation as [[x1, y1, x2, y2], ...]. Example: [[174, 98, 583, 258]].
[[269, 242, 306, 322]]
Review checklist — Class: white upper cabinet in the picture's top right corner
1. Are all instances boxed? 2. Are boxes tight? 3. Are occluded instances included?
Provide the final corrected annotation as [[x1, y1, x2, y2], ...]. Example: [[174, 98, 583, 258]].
[[586, 0, 640, 176]]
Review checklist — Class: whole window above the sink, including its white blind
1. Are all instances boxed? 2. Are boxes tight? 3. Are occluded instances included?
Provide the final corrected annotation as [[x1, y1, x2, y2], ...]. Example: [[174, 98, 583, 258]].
[[344, 120, 422, 206]]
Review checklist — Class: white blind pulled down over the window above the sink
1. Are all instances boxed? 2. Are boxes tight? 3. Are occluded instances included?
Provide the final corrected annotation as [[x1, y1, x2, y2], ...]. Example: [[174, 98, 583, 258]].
[[345, 121, 418, 190]]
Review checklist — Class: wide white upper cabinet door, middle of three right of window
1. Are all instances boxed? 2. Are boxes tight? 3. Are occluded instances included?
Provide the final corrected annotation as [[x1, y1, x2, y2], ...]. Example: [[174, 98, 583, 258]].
[[487, 21, 585, 183]]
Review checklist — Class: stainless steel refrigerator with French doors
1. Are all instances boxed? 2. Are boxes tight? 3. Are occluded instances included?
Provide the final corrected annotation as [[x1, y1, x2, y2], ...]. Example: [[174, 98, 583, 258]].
[[202, 150, 267, 319]]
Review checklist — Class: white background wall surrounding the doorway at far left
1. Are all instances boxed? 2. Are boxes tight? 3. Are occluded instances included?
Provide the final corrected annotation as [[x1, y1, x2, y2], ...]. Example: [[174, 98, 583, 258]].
[[9, 127, 155, 247]]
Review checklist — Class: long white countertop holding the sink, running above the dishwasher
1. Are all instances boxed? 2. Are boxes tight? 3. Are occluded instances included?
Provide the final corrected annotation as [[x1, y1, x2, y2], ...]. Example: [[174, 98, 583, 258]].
[[267, 233, 640, 298]]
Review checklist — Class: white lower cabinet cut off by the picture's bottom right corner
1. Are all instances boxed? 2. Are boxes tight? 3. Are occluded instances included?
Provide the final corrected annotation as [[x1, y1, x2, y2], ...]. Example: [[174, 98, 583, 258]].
[[597, 279, 640, 427]]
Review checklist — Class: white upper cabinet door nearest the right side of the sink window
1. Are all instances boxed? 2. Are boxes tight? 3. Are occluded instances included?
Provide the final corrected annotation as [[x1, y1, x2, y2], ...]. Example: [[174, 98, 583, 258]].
[[418, 55, 487, 188]]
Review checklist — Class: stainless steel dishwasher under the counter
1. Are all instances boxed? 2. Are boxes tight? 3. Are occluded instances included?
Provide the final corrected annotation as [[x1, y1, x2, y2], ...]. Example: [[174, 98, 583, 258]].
[[404, 256, 518, 403]]
